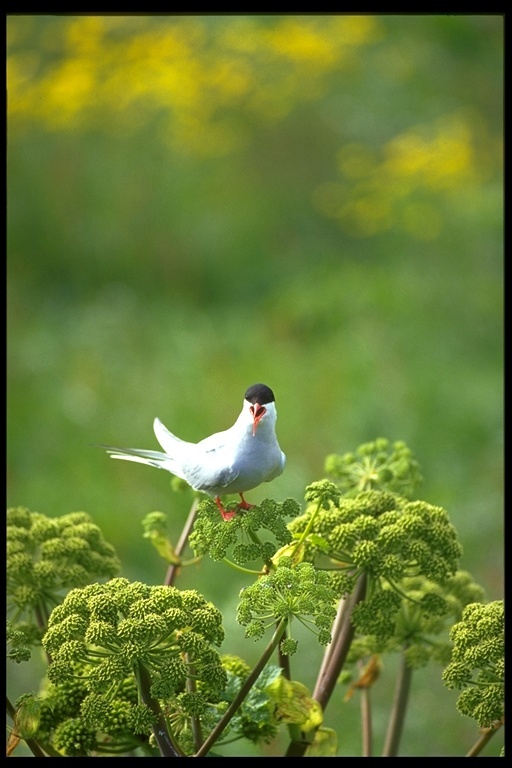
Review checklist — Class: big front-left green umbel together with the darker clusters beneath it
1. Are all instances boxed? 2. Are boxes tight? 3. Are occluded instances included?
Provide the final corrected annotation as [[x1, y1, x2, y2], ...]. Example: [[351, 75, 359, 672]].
[[10, 578, 226, 756]]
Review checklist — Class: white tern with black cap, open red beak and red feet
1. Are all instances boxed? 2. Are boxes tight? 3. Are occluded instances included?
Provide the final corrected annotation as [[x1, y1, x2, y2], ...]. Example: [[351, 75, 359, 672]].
[[101, 384, 286, 520]]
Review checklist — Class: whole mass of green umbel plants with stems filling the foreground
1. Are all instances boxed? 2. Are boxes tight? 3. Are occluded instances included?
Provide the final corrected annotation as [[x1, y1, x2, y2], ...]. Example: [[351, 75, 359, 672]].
[[7, 440, 504, 757]]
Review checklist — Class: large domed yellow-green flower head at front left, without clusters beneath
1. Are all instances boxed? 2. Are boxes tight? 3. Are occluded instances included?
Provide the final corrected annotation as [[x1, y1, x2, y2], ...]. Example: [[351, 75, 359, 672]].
[[43, 578, 225, 699]]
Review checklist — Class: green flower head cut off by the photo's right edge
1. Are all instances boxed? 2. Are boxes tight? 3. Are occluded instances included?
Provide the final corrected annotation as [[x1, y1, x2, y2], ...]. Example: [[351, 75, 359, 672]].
[[443, 600, 505, 728]]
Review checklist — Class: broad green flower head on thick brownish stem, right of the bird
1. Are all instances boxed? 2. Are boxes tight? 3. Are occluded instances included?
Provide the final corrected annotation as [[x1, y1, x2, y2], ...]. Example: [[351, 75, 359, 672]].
[[289, 492, 462, 643]]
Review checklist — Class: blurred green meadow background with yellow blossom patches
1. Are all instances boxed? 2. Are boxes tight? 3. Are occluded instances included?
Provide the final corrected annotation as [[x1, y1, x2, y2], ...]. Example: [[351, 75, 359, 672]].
[[7, 15, 503, 756]]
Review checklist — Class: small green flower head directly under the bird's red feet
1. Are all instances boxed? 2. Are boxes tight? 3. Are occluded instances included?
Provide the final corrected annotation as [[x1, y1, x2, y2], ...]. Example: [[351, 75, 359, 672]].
[[189, 499, 299, 565]]
